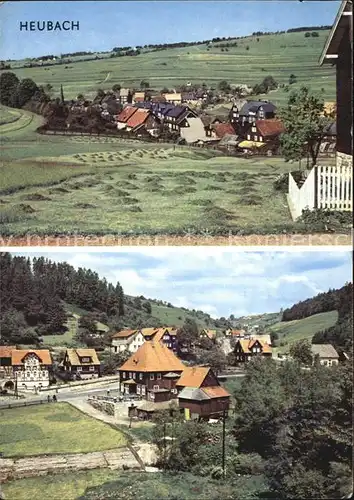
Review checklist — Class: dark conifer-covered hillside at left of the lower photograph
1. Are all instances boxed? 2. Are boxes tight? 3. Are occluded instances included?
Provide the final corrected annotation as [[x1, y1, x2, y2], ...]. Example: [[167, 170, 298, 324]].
[[0, 253, 216, 344]]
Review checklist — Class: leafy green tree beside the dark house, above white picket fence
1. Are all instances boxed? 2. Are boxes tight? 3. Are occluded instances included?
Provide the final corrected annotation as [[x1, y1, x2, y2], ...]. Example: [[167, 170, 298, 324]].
[[280, 87, 331, 166]]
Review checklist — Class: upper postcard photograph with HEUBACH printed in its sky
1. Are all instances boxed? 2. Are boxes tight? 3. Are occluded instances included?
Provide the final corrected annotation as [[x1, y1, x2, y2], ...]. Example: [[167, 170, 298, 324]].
[[0, 0, 353, 247]]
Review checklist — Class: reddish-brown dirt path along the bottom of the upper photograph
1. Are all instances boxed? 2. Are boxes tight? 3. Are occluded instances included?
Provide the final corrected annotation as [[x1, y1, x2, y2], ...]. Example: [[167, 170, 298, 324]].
[[0, 233, 352, 247]]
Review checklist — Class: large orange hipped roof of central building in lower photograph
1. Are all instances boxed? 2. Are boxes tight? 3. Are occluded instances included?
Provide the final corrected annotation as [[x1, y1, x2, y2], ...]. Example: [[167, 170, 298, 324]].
[[119, 341, 185, 372]]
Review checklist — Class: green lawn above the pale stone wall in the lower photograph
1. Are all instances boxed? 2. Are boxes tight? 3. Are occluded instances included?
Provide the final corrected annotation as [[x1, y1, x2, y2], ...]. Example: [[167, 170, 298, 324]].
[[0, 403, 126, 457]]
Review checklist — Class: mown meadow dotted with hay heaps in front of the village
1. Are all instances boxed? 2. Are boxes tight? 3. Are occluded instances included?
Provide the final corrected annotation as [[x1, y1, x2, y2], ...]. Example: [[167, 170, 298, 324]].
[[0, 139, 293, 235]]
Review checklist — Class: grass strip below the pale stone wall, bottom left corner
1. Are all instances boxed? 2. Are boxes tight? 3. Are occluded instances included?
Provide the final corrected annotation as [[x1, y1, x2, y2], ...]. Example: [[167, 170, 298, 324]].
[[2, 469, 117, 500]]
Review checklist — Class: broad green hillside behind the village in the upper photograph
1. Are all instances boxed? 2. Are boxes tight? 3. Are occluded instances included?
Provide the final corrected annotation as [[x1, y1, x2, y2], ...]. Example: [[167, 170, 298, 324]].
[[6, 30, 335, 104]]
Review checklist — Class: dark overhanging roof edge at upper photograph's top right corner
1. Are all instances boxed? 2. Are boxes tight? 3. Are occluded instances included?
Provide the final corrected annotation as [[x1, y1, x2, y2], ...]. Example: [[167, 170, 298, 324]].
[[319, 0, 352, 66]]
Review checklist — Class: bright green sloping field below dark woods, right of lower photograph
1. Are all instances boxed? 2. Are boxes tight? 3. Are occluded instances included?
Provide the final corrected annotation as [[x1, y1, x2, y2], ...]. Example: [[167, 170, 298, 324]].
[[269, 311, 338, 353]]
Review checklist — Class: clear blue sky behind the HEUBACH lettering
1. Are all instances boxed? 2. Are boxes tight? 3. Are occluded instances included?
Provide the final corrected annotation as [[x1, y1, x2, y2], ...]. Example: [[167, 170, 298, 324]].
[[0, 0, 340, 60]]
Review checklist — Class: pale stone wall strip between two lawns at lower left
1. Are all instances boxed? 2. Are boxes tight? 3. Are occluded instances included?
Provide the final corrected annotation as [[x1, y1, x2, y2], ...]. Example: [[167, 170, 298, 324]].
[[0, 448, 141, 483]]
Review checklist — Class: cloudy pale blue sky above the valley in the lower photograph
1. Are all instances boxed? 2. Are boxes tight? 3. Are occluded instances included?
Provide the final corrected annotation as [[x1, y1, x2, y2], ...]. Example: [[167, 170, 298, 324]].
[[13, 247, 352, 318]]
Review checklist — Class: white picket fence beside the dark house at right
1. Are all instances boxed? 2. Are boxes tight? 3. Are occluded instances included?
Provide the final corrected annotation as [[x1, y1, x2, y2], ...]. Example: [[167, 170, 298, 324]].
[[288, 165, 353, 220]]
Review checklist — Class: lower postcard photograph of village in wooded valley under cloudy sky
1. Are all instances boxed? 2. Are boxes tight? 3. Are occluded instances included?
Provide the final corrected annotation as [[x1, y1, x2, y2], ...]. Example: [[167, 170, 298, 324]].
[[0, 247, 353, 500]]
